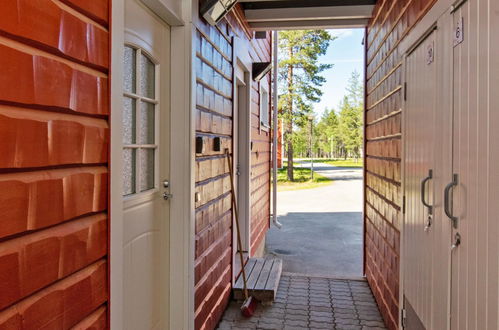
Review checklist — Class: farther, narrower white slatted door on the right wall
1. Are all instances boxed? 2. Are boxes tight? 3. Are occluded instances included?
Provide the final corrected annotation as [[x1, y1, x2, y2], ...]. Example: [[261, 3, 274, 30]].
[[402, 32, 437, 328]]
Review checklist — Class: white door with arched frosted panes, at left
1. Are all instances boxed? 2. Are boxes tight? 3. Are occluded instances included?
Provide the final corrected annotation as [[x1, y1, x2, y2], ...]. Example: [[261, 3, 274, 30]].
[[123, 0, 170, 330]]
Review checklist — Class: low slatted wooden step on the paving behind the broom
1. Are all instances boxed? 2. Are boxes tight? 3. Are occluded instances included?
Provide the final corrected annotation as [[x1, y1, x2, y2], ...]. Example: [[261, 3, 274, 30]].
[[233, 258, 282, 302]]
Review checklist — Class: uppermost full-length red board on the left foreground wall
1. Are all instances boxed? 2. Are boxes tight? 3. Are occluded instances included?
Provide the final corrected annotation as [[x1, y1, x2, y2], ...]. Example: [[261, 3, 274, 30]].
[[0, 0, 109, 69]]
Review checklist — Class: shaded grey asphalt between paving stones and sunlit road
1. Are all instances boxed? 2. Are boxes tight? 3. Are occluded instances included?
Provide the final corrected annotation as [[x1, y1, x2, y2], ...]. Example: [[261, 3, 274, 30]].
[[266, 212, 363, 277]]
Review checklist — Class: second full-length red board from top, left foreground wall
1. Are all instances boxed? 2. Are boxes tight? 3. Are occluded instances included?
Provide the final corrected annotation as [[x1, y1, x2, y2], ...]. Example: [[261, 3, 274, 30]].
[[0, 45, 109, 115]]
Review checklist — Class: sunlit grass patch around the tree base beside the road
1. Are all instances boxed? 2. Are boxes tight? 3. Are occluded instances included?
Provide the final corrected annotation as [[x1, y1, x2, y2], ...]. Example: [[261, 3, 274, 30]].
[[277, 167, 333, 191]]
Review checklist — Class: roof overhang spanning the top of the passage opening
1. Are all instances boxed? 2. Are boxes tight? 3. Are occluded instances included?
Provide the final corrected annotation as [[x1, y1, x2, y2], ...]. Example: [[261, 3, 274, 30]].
[[239, 0, 376, 31]]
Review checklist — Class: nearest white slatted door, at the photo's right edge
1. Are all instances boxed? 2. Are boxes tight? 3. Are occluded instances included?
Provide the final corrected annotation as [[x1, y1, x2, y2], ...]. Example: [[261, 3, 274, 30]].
[[451, 0, 499, 330]]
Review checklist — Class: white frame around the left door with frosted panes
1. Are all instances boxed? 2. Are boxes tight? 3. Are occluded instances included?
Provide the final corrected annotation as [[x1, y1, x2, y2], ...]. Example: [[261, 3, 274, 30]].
[[109, 0, 195, 329]]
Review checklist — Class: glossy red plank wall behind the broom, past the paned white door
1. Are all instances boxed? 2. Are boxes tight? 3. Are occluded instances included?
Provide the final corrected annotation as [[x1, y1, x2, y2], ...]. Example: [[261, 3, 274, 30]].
[[194, 3, 270, 329]]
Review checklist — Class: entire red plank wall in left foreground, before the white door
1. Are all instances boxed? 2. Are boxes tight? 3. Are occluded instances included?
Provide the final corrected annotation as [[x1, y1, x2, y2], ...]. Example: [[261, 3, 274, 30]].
[[0, 0, 109, 329]]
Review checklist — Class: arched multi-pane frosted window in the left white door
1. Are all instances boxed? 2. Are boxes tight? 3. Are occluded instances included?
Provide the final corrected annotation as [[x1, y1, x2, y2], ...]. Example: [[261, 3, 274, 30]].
[[123, 45, 158, 196]]
